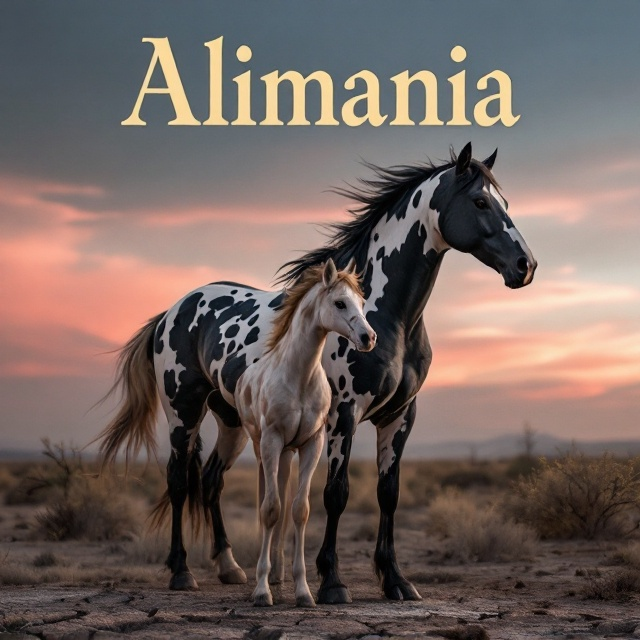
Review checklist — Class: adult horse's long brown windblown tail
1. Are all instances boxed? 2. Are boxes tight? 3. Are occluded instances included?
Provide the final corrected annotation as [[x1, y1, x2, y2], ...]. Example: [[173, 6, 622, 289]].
[[96, 313, 164, 468]]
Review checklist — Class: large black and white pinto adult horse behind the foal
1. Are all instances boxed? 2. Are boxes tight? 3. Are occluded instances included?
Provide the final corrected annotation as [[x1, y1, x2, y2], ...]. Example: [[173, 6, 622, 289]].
[[101, 144, 537, 603]]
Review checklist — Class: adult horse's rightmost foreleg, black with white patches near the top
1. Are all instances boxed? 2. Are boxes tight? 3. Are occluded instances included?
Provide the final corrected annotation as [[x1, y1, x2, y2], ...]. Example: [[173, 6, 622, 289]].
[[374, 399, 422, 600]]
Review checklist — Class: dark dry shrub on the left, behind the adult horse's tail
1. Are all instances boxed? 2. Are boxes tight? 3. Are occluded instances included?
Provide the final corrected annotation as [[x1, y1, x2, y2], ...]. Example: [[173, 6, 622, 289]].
[[36, 478, 138, 540]]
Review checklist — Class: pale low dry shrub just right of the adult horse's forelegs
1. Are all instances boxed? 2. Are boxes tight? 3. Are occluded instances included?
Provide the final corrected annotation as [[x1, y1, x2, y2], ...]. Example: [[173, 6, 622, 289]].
[[428, 491, 537, 562]]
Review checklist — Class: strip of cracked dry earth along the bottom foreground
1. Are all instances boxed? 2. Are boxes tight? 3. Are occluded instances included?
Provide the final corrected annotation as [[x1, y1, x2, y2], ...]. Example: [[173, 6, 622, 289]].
[[0, 571, 640, 640]]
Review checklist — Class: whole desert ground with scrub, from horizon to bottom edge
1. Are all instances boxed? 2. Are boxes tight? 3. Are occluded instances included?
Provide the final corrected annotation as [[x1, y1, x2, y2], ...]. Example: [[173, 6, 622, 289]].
[[0, 445, 640, 640]]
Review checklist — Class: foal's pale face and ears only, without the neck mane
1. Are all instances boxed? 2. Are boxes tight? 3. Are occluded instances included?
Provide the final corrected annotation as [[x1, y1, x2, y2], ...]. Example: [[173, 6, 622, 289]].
[[318, 258, 377, 351]]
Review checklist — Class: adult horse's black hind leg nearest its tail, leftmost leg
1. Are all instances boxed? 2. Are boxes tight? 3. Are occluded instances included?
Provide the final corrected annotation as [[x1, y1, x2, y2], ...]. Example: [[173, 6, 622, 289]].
[[167, 427, 198, 591]]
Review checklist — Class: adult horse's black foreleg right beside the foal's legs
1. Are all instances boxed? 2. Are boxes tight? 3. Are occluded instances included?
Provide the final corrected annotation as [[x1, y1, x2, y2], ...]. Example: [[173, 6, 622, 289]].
[[316, 401, 356, 604]]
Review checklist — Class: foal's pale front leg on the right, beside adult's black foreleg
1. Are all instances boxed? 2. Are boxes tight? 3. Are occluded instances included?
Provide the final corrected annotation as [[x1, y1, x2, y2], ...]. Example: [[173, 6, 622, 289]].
[[292, 427, 324, 607]]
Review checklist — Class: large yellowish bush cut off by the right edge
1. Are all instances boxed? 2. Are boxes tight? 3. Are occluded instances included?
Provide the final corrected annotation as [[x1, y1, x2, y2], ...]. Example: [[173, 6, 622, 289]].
[[507, 454, 640, 539]]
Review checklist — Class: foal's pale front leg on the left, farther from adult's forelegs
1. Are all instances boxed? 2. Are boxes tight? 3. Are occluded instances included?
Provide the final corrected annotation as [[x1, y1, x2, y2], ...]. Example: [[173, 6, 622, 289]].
[[252, 424, 284, 607]]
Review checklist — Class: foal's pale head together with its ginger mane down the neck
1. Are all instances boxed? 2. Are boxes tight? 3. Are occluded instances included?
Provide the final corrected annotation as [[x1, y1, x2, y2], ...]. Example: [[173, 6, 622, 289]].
[[267, 258, 377, 351]]
